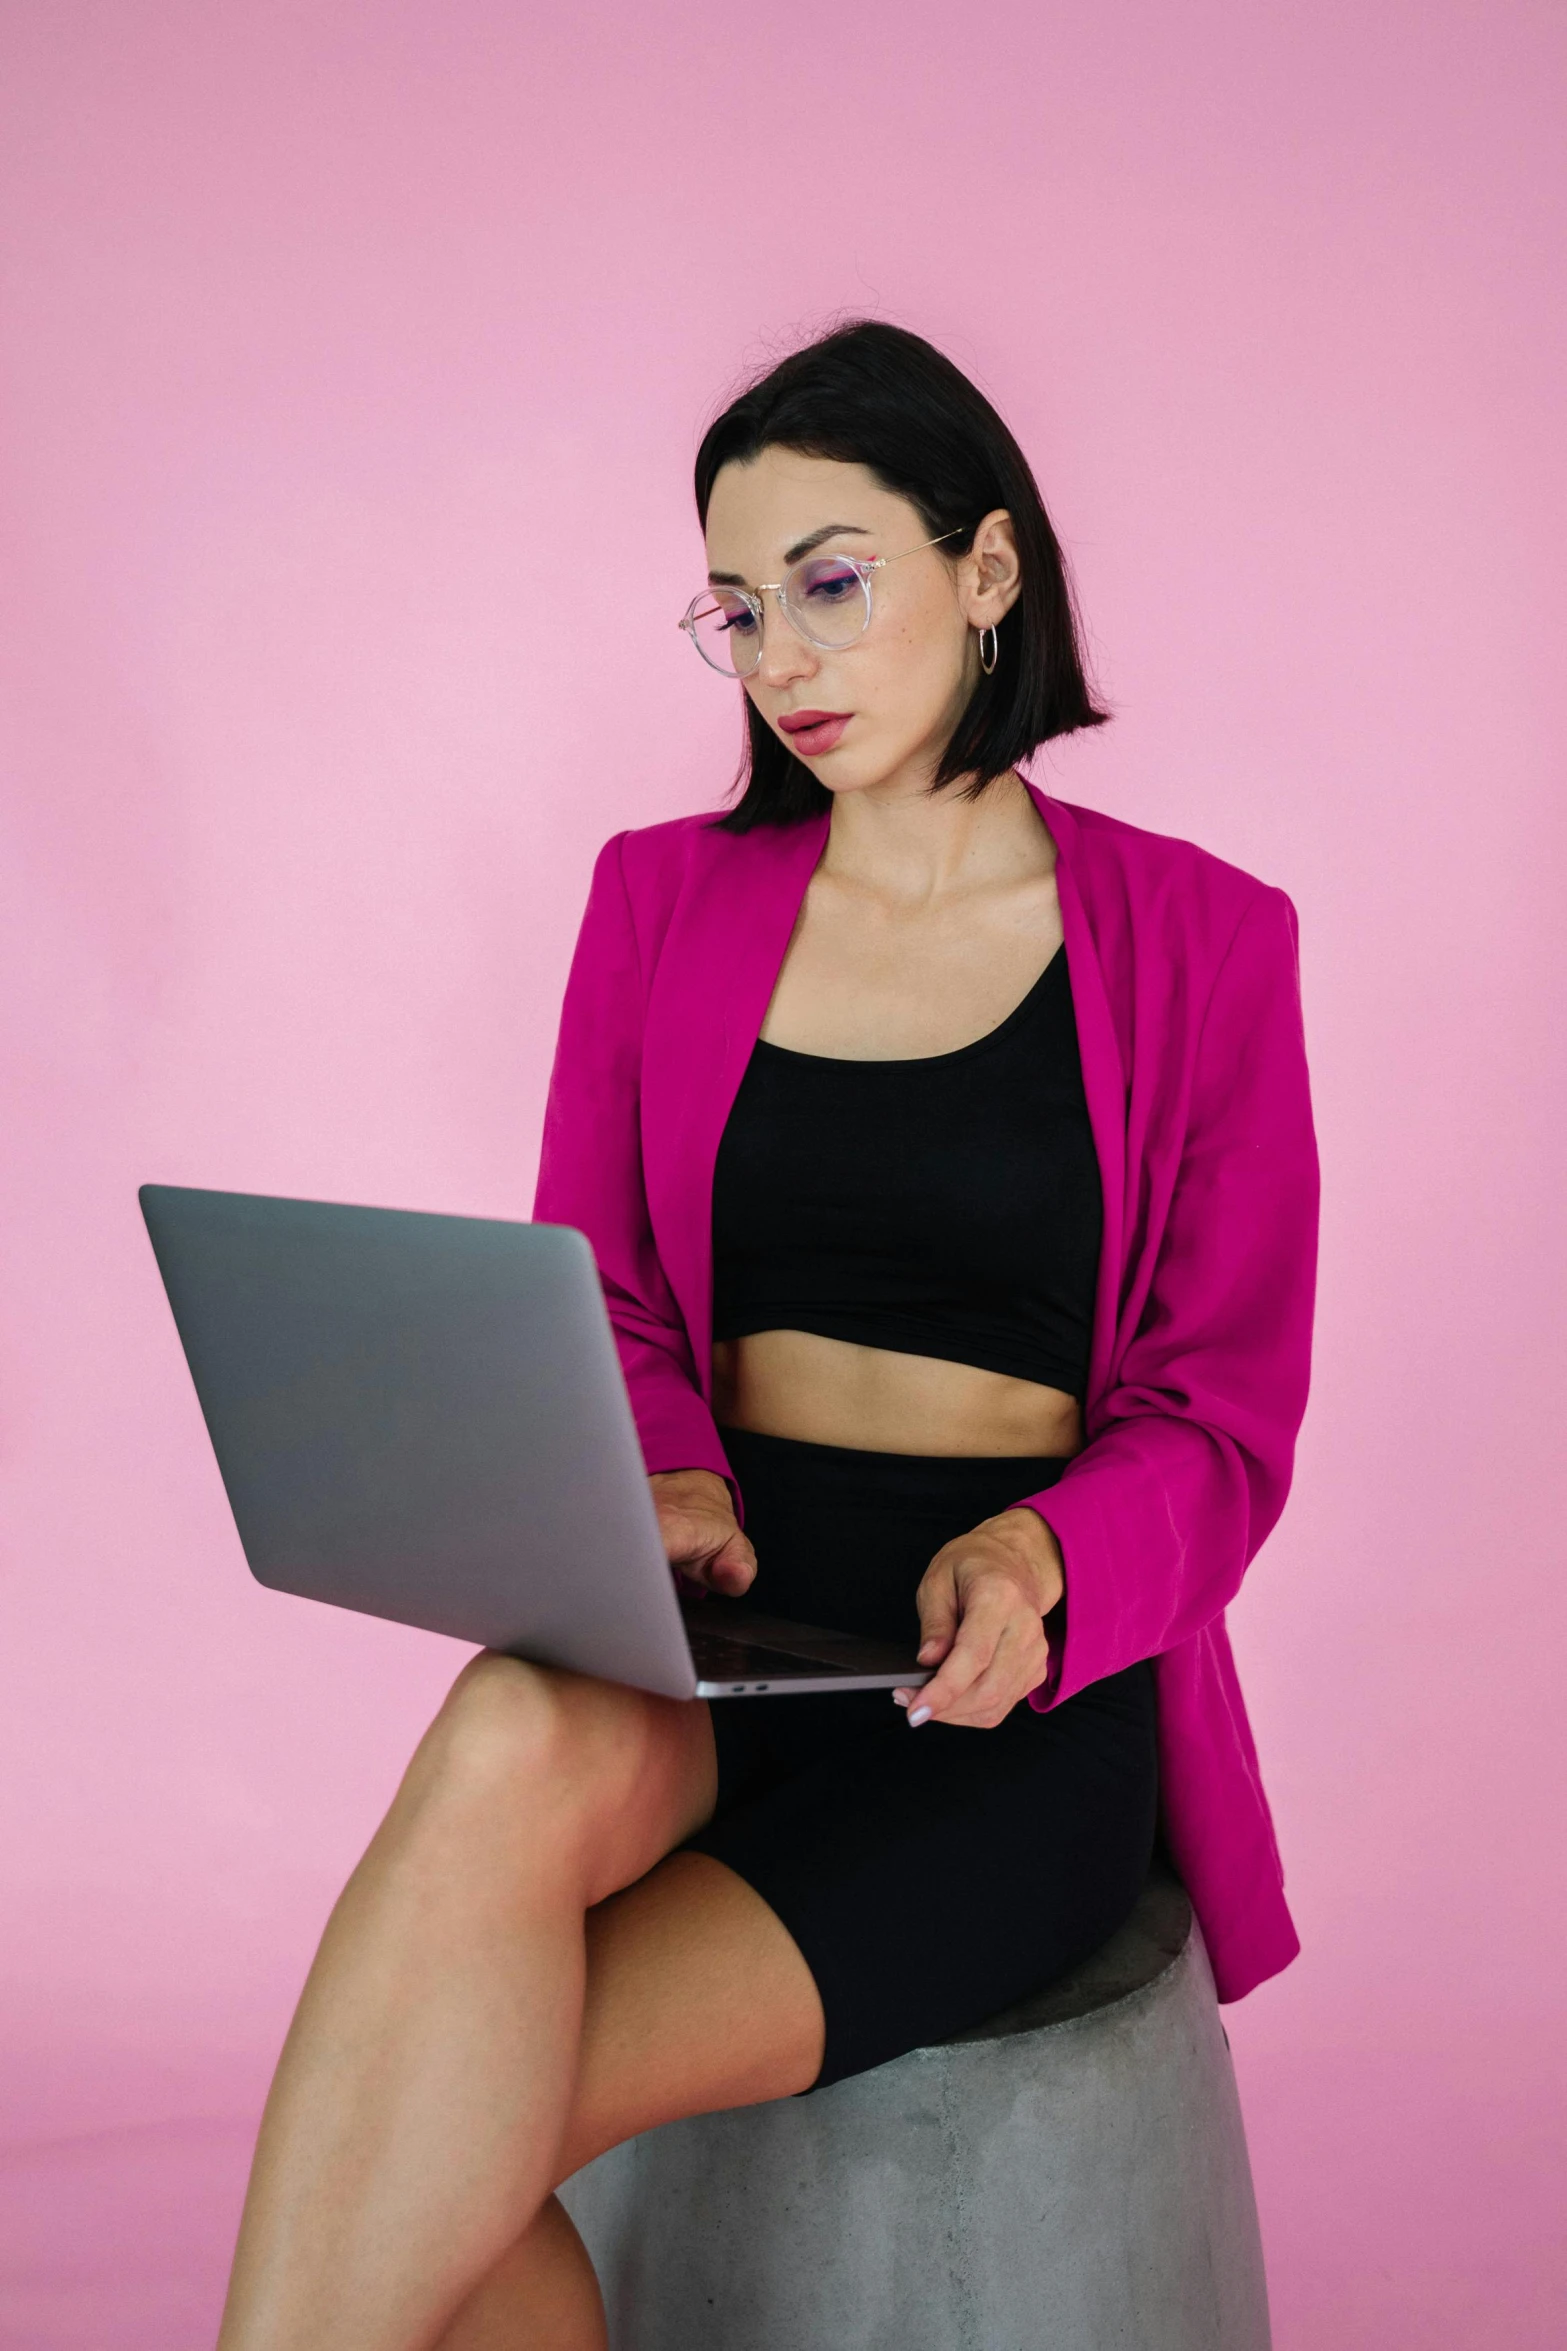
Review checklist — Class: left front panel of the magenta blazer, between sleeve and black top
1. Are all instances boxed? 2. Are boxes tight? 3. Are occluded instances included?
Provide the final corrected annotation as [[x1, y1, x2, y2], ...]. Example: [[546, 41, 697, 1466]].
[[641, 816, 827, 1399]]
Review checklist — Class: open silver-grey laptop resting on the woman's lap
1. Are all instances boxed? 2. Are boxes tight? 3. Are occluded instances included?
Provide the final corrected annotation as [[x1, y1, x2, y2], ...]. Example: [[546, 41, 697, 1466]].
[[139, 1185, 930, 1697]]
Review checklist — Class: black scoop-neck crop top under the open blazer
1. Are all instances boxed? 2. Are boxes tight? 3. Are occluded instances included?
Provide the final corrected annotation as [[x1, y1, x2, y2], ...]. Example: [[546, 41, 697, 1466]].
[[712, 950, 1102, 1396]]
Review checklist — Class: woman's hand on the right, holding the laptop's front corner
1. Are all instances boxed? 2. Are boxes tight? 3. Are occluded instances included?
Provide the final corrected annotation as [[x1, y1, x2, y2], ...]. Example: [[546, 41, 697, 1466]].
[[893, 1509, 1067, 1730]]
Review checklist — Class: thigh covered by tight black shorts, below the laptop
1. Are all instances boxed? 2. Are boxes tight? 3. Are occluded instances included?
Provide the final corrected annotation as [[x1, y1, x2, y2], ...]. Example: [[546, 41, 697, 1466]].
[[688, 1665, 1158, 2085]]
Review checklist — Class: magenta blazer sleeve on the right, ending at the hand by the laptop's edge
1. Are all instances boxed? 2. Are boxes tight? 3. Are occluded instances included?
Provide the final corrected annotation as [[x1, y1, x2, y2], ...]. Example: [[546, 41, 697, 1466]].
[[1024, 891, 1318, 1709]]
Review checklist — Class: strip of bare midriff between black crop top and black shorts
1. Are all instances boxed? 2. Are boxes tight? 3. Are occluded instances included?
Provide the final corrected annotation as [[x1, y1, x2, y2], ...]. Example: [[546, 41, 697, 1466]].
[[712, 1331, 1083, 1455]]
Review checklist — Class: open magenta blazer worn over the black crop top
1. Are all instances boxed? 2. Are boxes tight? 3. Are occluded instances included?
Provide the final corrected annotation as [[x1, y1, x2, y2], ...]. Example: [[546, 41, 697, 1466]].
[[533, 788, 1318, 2001]]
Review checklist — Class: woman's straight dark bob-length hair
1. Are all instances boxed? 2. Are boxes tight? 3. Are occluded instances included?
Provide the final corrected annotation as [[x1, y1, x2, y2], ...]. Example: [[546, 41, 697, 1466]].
[[695, 320, 1109, 832]]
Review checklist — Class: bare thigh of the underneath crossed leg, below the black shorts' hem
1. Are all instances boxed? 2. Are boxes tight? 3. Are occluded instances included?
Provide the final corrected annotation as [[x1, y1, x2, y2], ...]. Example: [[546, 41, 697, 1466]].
[[557, 1853, 825, 2179]]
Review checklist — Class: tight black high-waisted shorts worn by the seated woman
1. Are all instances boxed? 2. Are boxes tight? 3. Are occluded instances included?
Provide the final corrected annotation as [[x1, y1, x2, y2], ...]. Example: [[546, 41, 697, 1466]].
[[686, 1429, 1158, 2090]]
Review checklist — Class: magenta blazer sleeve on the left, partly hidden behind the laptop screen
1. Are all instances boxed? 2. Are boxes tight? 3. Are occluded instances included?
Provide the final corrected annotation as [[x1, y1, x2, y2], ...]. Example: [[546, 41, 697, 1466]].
[[533, 835, 733, 1486]]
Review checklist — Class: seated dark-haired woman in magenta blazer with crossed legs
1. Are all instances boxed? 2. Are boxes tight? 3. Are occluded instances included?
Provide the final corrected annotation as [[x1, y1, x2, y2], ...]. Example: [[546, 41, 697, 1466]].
[[221, 324, 1316, 2351]]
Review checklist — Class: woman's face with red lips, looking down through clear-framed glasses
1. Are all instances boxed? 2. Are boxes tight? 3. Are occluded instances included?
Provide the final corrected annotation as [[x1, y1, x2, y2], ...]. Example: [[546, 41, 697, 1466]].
[[707, 449, 1017, 792]]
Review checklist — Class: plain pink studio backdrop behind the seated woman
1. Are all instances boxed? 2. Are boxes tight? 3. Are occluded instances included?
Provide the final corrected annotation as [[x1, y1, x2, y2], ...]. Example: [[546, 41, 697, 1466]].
[[0, 0, 1567, 2351]]
